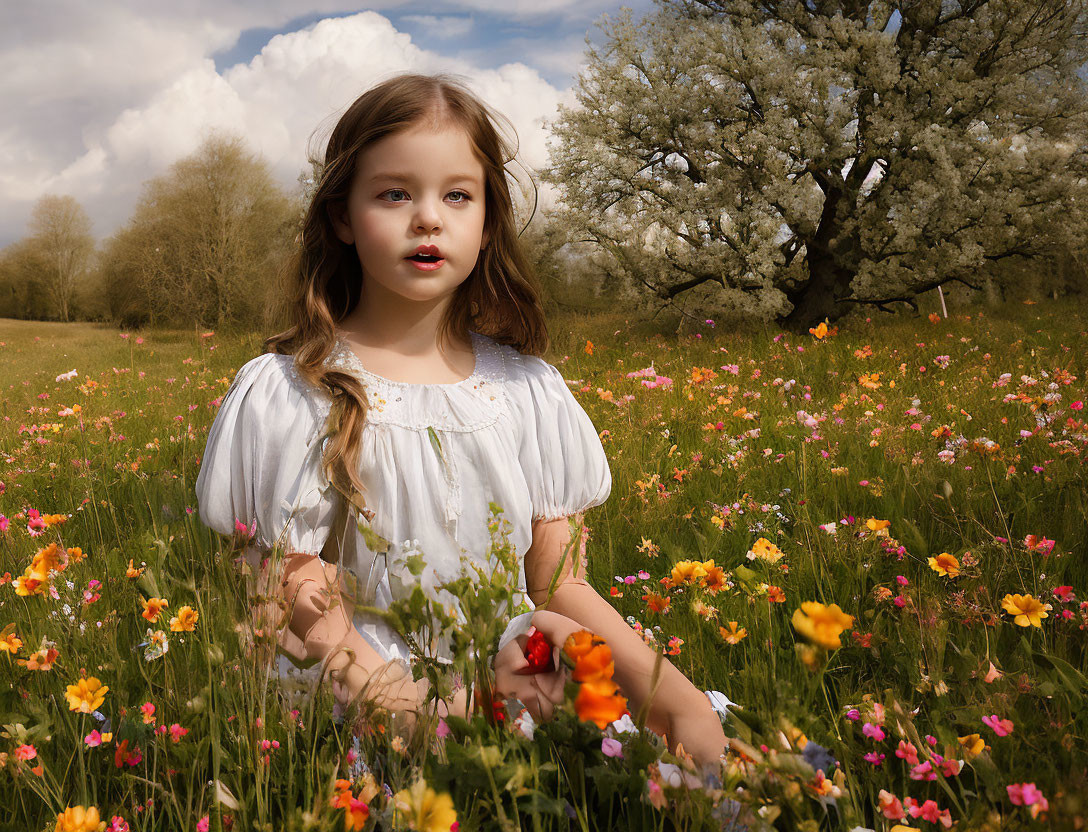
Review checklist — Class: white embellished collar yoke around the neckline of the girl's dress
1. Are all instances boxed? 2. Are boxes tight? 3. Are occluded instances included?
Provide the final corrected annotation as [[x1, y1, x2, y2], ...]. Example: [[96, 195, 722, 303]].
[[325, 331, 509, 432]]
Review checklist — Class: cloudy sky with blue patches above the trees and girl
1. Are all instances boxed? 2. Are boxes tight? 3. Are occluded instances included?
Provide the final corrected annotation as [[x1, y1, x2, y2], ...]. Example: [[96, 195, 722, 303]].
[[0, 0, 653, 247]]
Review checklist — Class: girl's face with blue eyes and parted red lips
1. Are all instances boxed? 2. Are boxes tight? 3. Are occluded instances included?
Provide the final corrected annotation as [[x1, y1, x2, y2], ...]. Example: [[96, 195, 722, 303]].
[[333, 125, 487, 301]]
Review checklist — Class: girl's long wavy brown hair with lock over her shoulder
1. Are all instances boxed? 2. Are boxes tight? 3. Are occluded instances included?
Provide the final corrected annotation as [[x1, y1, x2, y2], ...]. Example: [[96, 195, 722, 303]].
[[264, 74, 549, 517]]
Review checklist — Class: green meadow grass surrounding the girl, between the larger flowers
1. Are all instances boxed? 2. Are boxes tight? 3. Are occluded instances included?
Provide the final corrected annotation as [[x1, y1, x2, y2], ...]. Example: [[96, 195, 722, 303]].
[[0, 303, 1088, 829]]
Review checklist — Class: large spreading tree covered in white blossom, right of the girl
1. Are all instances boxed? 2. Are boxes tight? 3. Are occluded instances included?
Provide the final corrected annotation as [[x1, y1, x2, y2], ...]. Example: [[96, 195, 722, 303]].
[[544, 0, 1088, 330]]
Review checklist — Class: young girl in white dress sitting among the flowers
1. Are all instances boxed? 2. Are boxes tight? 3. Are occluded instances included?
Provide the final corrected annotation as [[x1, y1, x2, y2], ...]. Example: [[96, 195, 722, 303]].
[[196, 75, 728, 763]]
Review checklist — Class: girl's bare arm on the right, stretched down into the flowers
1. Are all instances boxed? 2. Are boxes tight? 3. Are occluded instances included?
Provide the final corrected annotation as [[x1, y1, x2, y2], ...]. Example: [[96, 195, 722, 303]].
[[526, 518, 726, 765]]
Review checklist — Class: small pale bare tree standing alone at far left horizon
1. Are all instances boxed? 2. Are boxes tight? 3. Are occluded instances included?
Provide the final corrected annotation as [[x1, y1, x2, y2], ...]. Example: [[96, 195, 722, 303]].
[[29, 195, 95, 321]]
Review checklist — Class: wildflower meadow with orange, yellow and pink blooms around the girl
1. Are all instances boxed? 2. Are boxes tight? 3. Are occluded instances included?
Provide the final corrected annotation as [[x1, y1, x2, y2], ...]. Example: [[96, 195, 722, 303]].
[[0, 302, 1088, 832]]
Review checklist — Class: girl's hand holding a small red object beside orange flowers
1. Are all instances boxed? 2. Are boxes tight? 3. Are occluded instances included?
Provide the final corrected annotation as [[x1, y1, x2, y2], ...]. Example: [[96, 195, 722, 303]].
[[495, 610, 584, 722]]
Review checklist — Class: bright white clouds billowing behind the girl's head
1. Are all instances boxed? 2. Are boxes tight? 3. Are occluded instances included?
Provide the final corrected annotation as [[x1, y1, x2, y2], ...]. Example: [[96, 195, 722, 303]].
[[0, 7, 570, 245]]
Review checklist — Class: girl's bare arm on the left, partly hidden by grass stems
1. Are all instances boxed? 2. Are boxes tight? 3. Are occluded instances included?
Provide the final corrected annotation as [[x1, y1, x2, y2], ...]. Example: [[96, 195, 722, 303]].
[[258, 555, 468, 731]]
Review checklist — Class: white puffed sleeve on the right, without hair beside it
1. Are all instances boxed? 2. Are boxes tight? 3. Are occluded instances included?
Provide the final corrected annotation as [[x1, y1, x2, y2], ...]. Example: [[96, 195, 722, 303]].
[[512, 356, 611, 520]]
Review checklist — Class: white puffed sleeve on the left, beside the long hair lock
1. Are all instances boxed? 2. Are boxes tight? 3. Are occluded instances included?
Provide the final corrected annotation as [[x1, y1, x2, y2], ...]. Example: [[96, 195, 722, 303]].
[[196, 352, 341, 554]]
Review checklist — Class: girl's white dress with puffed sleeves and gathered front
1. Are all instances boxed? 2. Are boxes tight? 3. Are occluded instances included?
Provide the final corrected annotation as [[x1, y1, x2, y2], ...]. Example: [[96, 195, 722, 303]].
[[196, 332, 611, 678]]
